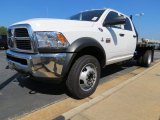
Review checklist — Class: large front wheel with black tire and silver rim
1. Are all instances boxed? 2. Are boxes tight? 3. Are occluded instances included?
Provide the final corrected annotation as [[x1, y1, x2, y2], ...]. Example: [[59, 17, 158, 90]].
[[66, 55, 101, 99]]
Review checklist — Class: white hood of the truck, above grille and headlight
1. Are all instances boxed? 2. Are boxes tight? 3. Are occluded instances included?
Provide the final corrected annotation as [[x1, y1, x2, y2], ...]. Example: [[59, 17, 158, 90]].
[[13, 18, 94, 31]]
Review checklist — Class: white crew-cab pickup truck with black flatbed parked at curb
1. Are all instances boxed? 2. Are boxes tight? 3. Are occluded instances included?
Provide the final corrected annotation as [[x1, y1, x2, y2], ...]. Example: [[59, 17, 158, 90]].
[[6, 9, 154, 99]]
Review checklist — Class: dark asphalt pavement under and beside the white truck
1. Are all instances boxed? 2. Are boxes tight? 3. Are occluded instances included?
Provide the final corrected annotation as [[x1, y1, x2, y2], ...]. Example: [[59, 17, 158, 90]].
[[0, 51, 160, 120]]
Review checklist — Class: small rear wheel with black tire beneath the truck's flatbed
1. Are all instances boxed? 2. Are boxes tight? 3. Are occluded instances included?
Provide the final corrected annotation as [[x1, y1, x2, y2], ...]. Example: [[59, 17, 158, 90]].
[[137, 50, 152, 67]]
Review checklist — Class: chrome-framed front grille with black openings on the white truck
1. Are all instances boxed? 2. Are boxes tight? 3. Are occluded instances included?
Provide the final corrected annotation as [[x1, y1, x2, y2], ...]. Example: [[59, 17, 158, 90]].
[[8, 25, 35, 53]]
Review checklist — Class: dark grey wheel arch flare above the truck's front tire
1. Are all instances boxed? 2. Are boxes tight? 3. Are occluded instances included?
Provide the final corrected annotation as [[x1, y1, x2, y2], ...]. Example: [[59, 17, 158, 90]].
[[63, 37, 106, 77]]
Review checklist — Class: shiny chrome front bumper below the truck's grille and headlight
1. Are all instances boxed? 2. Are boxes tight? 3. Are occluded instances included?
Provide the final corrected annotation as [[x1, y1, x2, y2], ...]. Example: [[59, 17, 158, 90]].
[[6, 50, 66, 78]]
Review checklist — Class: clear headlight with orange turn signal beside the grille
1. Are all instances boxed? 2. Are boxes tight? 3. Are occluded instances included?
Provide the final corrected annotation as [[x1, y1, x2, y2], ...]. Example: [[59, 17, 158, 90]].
[[35, 32, 69, 49]]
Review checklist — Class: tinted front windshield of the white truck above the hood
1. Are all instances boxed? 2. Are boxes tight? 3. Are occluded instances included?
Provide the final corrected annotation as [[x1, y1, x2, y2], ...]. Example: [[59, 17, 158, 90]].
[[69, 10, 105, 22]]
